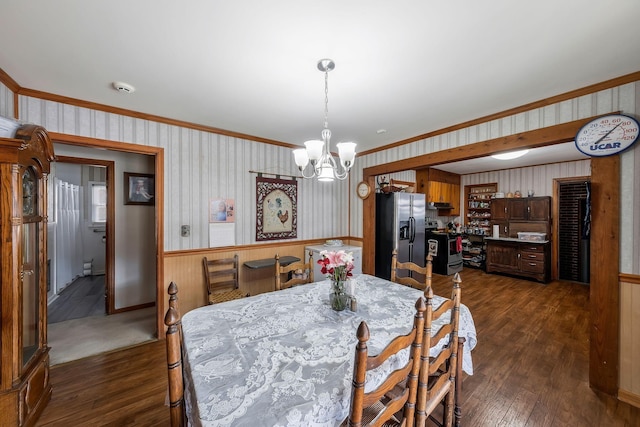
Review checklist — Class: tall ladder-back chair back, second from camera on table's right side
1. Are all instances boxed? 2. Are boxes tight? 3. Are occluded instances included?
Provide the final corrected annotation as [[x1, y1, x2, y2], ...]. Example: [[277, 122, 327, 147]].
[[416, 273, 462, 426]]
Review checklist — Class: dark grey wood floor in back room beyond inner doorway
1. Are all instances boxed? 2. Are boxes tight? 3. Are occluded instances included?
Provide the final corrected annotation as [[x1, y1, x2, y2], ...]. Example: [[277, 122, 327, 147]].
[[47, 275, 105, 323]]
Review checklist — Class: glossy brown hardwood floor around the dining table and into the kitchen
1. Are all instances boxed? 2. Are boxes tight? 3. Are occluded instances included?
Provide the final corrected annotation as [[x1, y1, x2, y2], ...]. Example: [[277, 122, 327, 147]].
[[37, 269, 640, 427]]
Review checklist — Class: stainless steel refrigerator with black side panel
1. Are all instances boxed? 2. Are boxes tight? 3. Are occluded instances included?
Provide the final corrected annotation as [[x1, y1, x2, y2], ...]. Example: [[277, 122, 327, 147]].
[[376, 193, 426, 280]]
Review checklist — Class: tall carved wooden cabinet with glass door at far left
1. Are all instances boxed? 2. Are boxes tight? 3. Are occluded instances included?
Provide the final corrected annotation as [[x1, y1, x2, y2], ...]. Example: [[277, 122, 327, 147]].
[[0, 125, 54, 426]]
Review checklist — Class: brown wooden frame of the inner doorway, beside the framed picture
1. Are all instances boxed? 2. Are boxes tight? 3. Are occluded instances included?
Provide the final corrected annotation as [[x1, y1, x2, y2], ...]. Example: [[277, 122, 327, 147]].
[[55, 156, 116, 315]]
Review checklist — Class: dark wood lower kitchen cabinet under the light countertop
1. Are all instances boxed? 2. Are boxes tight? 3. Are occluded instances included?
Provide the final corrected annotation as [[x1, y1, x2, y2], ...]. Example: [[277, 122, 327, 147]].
[[486, 238, 551, 283]]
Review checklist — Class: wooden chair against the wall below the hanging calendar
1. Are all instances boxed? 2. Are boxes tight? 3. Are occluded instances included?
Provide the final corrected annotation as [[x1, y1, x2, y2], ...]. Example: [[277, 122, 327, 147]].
[[202, 254, 249, 304]]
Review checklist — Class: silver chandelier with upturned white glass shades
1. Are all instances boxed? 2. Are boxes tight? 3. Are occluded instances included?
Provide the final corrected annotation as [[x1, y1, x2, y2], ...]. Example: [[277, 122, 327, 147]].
[[293, 59, 356, 181]]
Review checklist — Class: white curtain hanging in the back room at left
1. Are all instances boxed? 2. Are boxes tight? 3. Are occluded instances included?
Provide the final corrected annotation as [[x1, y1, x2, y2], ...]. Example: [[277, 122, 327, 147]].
[[55, 178, 83, 290]]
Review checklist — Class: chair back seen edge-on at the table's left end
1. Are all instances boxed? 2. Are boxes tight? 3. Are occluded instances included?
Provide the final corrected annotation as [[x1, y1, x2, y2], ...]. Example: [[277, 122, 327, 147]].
[[164, 282, 187, 427]]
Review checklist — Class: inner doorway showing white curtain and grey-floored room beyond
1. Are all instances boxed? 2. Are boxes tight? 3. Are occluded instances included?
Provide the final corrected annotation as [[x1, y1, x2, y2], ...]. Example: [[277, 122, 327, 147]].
[[47, 156, 115, 314]]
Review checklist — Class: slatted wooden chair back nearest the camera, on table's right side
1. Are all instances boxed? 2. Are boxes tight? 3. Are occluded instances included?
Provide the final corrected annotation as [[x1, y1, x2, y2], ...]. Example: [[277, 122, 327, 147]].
[[343, 297, 426, 427]]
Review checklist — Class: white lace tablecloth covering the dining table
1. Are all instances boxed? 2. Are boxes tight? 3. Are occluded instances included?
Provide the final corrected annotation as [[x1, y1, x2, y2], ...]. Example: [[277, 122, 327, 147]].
[[182, 275, 476, 427]]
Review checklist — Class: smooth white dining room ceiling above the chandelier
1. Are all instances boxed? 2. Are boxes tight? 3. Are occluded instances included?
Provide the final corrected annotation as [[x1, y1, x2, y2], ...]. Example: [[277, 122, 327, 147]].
[[0, 0, 640, 168]]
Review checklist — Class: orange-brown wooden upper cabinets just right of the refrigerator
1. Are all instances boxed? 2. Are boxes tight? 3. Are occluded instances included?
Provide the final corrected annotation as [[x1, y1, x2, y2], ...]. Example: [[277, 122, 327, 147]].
[[416, 168, 460, 216]]
